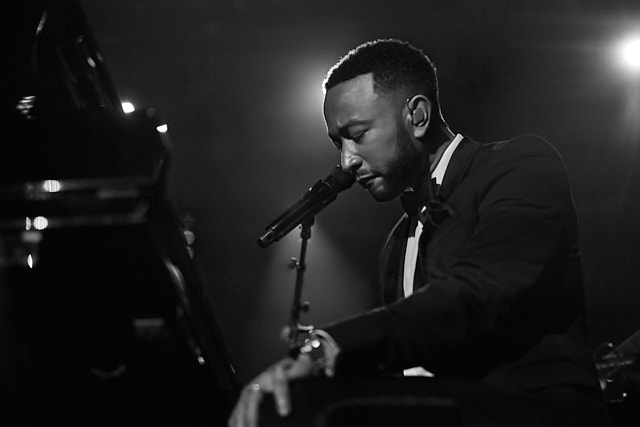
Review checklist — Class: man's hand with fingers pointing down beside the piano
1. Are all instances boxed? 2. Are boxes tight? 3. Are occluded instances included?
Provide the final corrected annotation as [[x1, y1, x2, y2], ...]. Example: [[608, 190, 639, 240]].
[[229, 355, 313, 427]]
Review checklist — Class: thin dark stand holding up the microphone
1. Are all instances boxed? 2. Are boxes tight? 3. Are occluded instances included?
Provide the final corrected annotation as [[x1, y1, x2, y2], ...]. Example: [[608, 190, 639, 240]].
[[289, 215, 314, 357]]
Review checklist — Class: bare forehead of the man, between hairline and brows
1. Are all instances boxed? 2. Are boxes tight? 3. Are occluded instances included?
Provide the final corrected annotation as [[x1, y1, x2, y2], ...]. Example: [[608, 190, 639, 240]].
[[324, 74, 392, 127]]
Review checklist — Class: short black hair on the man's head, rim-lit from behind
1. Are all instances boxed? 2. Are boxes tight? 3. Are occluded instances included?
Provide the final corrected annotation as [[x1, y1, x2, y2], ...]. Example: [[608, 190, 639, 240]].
[[323, 39, 440, 113]]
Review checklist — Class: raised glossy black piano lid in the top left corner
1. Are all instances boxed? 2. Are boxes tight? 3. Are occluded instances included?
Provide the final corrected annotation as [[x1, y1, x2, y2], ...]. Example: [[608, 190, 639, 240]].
[[14, 0, 123, 114]]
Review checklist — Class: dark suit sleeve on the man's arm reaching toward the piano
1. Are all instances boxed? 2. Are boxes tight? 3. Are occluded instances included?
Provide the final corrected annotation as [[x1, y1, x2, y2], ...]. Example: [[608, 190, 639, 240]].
[[324, 139, 579, 373]]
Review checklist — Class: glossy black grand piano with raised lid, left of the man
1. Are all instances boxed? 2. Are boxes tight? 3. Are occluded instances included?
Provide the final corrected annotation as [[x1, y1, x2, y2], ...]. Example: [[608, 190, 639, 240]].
[[0, 0, 240, 426]]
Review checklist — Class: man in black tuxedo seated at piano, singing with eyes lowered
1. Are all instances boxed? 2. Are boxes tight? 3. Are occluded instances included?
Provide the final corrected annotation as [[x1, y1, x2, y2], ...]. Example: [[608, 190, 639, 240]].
[[229, 39, 609, 427]]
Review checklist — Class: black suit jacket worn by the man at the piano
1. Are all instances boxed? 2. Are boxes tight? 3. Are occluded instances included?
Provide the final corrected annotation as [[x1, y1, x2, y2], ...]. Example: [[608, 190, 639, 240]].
[[324, 135, 598, 391]]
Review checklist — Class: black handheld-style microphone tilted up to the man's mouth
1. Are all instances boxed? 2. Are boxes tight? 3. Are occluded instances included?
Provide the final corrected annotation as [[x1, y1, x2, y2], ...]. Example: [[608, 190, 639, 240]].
[[258, 165, 355, 248]]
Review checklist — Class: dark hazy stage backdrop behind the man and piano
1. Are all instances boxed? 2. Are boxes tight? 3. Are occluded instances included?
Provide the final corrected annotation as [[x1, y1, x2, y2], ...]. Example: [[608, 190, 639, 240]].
[[71, 0, 640, 382]]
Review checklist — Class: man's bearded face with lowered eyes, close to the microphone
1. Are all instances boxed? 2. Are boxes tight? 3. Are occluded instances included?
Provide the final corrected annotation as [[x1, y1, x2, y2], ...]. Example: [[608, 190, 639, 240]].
[[324, 74, 427, 202]]
